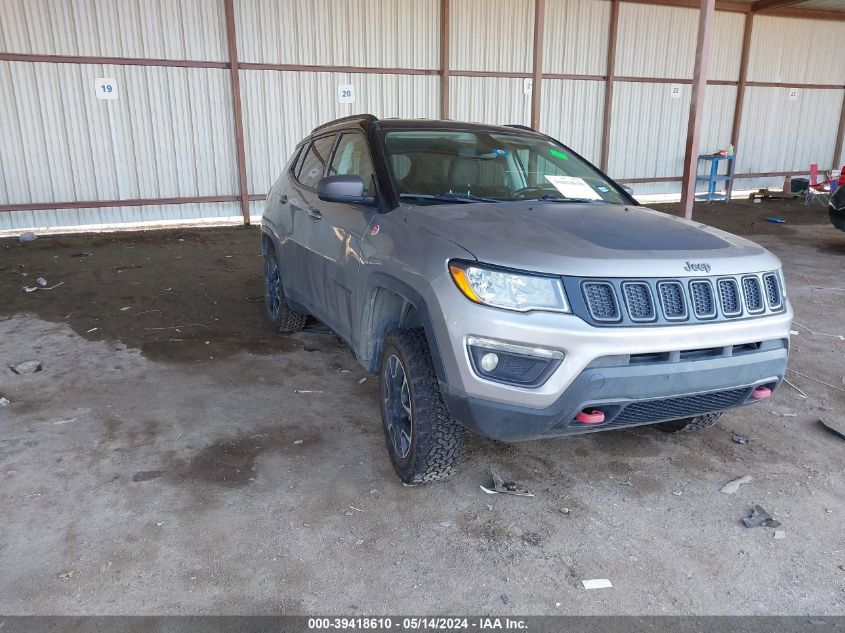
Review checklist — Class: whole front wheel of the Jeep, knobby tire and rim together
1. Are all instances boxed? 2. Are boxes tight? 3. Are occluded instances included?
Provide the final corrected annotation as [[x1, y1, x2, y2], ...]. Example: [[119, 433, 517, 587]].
[[379, 328, 466, 484]]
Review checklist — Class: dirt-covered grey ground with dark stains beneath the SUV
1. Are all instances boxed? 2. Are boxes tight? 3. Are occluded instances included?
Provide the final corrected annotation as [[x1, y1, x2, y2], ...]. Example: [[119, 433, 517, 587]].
[[0, 202, 845, 615]]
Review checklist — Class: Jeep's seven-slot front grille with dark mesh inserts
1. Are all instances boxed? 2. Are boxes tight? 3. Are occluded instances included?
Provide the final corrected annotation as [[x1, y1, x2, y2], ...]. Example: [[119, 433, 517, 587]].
[[581, 273, 784, 325]]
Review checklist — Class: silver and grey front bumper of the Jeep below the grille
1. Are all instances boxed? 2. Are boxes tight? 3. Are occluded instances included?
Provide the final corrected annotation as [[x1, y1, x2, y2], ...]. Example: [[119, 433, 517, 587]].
[[432, 276, 792, 440]]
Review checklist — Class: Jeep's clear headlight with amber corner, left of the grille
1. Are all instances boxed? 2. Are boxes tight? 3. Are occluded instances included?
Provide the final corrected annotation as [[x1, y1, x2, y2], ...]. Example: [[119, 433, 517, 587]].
[[449, 261, 569, 312]]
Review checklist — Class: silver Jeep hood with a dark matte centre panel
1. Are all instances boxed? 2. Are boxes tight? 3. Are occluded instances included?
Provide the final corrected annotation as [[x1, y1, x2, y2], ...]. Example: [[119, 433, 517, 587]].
[[405, 201, 780, 277]]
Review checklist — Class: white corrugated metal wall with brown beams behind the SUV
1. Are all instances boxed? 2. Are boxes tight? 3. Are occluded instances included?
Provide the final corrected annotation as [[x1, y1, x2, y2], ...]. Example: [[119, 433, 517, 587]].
[[0, 0, 845, 230]]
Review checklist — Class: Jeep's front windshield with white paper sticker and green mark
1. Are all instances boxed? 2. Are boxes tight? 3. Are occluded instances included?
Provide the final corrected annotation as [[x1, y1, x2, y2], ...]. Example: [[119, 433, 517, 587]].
[[385, 130, 628, 204]]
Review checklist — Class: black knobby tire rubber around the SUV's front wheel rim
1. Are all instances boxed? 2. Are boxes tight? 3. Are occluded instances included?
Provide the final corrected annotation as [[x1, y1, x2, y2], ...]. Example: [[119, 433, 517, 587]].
[[379, 328, 466, 484]]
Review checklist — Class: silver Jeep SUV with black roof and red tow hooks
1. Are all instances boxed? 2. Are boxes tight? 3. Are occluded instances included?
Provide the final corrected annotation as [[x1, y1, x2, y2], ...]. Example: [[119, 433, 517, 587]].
[[261, 115, 792, 483]]
